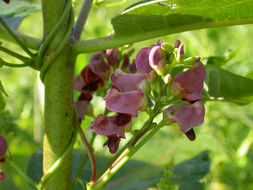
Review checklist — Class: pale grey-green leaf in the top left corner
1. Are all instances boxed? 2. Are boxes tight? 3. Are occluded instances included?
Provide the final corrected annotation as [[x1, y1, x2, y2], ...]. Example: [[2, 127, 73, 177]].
[[0, 0, 41, 30]]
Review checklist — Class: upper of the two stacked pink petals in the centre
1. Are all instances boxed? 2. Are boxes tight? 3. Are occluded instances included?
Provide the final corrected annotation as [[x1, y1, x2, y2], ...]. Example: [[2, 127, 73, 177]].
[[110, 69, 146, 92]]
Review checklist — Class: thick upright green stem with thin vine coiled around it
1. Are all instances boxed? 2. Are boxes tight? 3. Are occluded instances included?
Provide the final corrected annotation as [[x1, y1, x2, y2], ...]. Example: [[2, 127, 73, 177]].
[[42, 0, 75, 190]]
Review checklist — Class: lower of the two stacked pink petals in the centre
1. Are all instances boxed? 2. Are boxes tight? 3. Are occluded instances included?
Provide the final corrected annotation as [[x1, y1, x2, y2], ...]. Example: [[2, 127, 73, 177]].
[[105, 88, 146, 117]]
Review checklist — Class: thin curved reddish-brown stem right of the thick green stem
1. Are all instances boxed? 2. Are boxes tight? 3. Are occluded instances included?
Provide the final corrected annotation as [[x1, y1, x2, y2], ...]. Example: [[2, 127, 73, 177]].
[[77, 117, 97, 184]]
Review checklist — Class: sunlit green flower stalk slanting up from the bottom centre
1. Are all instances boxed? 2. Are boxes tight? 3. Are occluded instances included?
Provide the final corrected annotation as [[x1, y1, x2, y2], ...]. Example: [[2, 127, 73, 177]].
[[95, 118, 168, 187]]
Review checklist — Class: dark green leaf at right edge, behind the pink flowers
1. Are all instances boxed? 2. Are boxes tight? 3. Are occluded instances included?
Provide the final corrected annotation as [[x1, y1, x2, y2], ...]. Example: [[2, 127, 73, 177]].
[[204, 65, 253, 104]]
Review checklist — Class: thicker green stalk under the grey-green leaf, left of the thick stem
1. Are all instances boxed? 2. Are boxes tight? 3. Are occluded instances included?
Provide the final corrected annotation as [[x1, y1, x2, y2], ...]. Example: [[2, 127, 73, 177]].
[[0, 27, 41, 50]]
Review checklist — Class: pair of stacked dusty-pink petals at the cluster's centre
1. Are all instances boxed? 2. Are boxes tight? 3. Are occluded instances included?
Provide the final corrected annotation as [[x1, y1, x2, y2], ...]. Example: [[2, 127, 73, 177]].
[[105, 69, 146, 117]]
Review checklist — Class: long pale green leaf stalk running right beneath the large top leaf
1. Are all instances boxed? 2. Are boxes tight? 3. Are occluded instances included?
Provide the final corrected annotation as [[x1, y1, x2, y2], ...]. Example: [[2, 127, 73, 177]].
[[72, 18, 253, 54]]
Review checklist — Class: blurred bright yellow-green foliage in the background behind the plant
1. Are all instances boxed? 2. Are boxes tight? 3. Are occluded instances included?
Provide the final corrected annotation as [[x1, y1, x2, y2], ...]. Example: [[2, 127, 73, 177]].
[[0, 0, 253, 190]]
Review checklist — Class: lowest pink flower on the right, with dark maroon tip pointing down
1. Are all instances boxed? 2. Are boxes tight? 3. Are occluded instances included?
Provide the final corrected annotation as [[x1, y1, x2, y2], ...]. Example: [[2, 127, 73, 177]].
[[163, 101, 205, 140]]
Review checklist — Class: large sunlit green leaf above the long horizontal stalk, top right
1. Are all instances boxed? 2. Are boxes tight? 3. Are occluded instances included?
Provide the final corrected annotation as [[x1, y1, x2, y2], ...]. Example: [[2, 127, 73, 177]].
[[112, 0, 253, 43]]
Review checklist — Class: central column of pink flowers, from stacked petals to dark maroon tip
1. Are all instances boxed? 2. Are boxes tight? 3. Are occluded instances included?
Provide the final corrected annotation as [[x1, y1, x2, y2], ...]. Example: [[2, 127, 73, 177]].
[[89, 69, 146, 154]]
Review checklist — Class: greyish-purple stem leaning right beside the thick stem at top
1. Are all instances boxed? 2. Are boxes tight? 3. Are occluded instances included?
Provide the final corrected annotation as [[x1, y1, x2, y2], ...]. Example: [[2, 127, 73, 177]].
[[72, 0, 93, 41]]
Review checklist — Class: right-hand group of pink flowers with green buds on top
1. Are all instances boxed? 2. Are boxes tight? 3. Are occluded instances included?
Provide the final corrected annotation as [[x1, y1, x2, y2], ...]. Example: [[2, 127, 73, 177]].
[[136, 41, 205, 140]]
